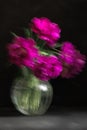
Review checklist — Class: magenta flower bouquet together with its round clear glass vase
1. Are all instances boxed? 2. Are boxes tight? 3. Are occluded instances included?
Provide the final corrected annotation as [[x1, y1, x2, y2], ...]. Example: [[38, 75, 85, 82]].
[[7, 17, 86, 115]]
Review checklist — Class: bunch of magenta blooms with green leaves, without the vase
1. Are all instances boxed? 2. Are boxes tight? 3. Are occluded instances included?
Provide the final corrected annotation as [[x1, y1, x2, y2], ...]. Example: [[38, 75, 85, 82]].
[[7, 17, 86, 81]]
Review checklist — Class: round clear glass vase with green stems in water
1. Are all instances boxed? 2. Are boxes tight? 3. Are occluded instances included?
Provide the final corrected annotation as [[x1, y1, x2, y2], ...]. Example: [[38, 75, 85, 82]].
[[11, 68, 53, 115]]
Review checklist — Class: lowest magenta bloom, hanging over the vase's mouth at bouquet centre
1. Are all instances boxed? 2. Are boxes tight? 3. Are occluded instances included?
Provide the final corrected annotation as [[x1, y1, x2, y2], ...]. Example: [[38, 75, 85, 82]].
[[33, 55, 62, 80]]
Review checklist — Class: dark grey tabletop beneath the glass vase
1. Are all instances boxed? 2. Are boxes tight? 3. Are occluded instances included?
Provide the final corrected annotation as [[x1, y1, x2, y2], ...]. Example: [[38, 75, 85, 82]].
[[0, 108, 87, 130]]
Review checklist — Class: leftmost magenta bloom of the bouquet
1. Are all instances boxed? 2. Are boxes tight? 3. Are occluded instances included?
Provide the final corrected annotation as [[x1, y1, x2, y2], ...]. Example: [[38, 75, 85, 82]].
[[7, 36, 39, 68]]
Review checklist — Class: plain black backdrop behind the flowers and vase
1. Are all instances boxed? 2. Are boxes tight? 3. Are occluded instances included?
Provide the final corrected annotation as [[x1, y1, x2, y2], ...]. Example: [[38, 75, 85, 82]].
[[0, 0, 87, 108]]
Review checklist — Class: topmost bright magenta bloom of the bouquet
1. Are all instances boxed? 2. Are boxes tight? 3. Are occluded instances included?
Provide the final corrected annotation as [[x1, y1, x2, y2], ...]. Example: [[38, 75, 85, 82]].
[[30, 17, 61, 46]]
